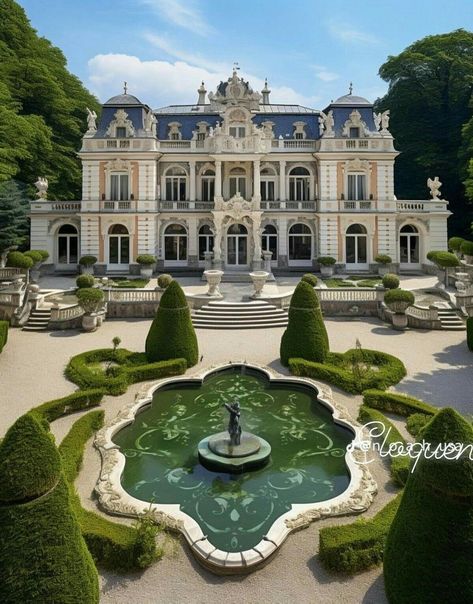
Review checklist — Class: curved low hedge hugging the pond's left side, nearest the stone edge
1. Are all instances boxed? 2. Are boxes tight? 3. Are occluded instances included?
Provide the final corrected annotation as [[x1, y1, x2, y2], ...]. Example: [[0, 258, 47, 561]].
[[59, 410, 161, 572]]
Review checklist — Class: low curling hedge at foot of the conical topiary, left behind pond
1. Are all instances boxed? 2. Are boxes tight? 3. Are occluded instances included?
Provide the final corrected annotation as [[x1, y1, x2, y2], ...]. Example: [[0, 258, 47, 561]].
[[65, 348, 187, 396]]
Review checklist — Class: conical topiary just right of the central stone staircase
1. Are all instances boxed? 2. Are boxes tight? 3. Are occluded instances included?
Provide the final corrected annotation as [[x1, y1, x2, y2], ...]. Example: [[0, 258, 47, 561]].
[[280, 281, 329, 366]]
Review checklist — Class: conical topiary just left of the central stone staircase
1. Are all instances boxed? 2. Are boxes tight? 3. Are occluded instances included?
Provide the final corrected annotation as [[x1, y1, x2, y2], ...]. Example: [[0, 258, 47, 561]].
[[146, 281, 199, 367]]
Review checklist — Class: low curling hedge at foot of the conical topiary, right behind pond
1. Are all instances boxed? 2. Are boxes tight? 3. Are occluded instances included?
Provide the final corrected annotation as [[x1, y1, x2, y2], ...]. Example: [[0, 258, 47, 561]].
[[289, 348, 406, 394]]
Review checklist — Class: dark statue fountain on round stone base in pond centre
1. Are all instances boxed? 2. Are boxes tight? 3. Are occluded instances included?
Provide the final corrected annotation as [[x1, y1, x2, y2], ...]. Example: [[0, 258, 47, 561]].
[[198, 399, 271, 472]]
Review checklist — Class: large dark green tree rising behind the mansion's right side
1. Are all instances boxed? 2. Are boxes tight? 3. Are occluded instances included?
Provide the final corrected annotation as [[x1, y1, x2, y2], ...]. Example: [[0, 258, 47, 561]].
[[377, 29, 473, 234]]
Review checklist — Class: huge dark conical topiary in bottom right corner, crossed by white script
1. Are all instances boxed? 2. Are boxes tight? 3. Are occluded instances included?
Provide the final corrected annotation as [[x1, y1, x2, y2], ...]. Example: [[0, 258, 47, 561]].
[[384, 409, 473, 604]]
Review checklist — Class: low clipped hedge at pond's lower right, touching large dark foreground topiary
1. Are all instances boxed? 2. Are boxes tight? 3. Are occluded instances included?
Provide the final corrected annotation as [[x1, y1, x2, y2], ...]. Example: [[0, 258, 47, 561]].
[[319, 494, 401, 574]]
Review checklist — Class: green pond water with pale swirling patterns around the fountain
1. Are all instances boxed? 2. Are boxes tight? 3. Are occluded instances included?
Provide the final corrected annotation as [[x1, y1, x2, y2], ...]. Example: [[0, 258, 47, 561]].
[[113, 366, 353, 552]]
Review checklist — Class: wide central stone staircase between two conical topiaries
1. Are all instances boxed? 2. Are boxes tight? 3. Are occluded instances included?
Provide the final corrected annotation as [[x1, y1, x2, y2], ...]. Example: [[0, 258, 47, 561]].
[[192, 300, 287, 329]]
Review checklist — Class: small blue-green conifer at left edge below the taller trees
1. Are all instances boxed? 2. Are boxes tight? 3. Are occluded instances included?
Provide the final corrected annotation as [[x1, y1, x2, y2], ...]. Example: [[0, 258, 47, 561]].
[[0, 180, 29, 254]]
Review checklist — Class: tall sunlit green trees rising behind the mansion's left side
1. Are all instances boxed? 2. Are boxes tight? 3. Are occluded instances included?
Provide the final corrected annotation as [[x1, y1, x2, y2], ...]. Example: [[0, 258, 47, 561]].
[[0, 0, 99, 199]]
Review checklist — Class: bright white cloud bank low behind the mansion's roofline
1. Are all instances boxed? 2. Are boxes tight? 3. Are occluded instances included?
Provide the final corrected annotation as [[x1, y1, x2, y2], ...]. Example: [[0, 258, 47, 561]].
[[88, 54, 321, 108]]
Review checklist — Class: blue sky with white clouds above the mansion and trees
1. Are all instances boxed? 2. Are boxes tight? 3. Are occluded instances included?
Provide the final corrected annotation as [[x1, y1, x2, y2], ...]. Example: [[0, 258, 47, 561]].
[[20, 0, 473, 108]]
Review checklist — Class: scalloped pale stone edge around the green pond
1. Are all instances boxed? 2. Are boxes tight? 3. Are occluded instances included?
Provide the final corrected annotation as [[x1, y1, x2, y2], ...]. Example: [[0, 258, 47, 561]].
[[94, 361, 377, 574]]
